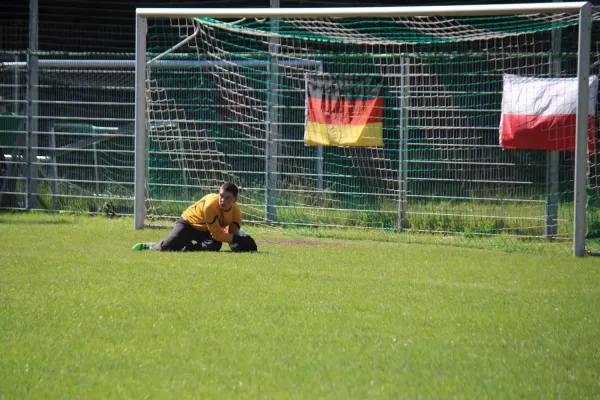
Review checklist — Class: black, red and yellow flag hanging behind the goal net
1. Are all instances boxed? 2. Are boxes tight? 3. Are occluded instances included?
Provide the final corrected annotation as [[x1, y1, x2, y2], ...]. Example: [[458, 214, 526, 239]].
[[304, 74, 383, 147]]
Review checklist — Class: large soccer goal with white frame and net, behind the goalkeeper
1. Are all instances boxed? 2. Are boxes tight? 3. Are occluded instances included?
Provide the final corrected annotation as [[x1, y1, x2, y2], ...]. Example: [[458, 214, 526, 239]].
[[135, 2, 600, 256]]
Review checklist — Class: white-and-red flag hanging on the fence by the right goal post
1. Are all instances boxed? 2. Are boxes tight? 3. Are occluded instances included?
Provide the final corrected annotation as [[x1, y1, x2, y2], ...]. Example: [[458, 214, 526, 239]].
[[500, 74, 598, 154]]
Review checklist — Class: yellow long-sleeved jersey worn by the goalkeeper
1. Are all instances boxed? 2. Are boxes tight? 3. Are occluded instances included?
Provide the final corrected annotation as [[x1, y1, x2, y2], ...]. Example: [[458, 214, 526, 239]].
[[181, 193, 242, 242]]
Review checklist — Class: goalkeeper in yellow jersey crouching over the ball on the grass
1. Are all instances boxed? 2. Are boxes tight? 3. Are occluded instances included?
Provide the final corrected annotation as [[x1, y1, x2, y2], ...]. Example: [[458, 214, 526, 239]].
[[132, 182, 257, 252]]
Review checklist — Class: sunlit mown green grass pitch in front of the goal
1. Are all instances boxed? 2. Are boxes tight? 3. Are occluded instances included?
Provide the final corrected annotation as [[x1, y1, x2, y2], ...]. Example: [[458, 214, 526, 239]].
[[0, 214, 600, 399]]
